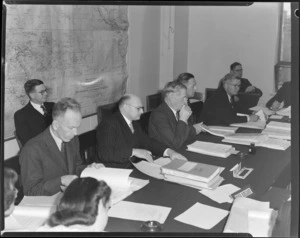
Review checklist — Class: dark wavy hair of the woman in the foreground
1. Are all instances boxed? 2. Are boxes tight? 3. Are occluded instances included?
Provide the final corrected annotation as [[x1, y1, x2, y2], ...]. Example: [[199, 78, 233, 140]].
[[48, 177, 111, 227]]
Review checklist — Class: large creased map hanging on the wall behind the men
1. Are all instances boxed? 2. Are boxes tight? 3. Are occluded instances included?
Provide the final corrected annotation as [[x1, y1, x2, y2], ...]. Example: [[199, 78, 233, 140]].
[[4, 5, 129, 138]]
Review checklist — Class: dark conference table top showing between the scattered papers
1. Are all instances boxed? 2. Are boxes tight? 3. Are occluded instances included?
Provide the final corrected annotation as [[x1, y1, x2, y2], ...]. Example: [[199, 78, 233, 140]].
[[106, 120, 291, 233]]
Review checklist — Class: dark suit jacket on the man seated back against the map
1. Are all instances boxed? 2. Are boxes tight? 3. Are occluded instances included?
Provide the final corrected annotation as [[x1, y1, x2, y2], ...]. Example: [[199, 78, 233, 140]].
[[14, 102, 54, 146]]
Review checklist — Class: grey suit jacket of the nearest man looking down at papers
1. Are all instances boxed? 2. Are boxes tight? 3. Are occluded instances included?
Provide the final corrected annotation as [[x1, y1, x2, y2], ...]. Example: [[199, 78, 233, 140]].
[[19, 127, 85, 196]]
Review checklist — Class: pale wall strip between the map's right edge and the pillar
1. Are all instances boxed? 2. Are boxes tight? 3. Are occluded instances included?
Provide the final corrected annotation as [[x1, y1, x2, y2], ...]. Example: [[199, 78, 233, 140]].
[[127, 6, 160, 106]]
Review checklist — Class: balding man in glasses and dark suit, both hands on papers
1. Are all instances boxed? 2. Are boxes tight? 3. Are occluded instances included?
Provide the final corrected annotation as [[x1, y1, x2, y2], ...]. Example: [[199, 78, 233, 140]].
[[97, 94, 186, 168]]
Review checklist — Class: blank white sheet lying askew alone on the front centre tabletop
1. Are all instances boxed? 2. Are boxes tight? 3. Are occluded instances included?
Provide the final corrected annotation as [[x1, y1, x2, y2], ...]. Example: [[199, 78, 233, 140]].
[[174, 203, 229, 230]]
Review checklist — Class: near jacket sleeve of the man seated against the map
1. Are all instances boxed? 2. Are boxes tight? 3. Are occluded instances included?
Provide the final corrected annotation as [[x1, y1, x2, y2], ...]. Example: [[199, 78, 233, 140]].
[[14, 112, 33, 146]]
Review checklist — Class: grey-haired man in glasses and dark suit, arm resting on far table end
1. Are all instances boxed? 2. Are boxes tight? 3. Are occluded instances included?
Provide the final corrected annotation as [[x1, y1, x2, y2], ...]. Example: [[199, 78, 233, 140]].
[[201, 74, 259, 126]]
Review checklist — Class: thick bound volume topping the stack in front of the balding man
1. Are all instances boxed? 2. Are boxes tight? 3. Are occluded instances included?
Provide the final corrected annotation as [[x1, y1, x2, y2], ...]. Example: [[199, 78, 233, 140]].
[[161, 159, 222, 183]]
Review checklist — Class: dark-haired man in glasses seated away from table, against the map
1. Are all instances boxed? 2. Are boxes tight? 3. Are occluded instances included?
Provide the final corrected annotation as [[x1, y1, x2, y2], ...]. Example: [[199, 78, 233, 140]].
[[14, 79, 54, 146]]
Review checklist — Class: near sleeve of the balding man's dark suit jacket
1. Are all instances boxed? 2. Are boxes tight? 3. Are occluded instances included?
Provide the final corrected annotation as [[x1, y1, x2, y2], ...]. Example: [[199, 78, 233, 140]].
[[97, 121, 132, 164]]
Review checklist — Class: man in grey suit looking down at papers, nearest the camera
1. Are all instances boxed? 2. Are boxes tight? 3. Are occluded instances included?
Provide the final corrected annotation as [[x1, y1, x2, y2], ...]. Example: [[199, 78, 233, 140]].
[[19, 98, 94, 196]]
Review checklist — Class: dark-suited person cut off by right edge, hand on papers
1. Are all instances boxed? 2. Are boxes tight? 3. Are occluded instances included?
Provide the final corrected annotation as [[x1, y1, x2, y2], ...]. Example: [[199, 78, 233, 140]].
[[266, 81, 292, 111]]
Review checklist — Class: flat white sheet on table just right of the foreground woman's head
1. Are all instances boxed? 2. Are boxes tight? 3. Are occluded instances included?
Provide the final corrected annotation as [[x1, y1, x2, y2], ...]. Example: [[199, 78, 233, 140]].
[[108, 201, 171, 224]]
